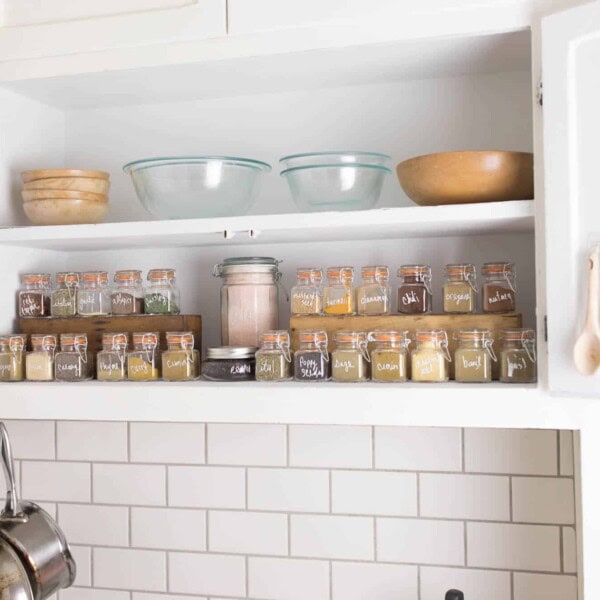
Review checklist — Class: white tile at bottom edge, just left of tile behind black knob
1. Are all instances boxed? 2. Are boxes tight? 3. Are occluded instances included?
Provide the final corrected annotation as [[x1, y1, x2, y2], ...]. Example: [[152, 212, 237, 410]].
[[332, 562, 420, 600]]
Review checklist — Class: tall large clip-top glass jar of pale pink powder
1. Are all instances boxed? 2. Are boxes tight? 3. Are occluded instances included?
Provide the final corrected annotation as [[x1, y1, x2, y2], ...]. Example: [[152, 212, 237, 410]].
[[213, 257, 281, 347]]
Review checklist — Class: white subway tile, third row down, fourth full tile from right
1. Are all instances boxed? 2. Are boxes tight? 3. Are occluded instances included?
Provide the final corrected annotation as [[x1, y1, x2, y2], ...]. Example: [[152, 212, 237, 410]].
[[208, 510, 288, 555]]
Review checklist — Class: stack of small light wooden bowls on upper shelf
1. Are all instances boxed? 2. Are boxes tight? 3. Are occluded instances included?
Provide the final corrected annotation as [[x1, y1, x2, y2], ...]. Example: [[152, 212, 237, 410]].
[[21, 169, 110, 225]]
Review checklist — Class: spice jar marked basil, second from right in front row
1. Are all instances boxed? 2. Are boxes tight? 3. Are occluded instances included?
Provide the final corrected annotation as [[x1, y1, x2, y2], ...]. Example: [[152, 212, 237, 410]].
[[454, 329, 498, 383]]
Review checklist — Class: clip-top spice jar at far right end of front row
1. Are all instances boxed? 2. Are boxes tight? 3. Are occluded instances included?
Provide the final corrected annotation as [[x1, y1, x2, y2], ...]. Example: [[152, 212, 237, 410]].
[[500, 329, 537, 383]]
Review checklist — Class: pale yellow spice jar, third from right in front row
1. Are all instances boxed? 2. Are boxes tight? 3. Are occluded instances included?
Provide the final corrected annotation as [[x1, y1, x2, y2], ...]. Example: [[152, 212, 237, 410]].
[[410, 329, 452, 383]]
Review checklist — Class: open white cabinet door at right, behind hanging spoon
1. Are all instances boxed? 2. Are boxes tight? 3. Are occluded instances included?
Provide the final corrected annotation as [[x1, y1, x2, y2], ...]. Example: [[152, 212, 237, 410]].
[[541, 2, 600, 397]]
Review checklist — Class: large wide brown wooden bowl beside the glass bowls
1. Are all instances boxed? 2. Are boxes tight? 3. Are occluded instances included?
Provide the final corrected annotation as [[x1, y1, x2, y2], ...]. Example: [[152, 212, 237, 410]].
[[396, 150, 533, 206]]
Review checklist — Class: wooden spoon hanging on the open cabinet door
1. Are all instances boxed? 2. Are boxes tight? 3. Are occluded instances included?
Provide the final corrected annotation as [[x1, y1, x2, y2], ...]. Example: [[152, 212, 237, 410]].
[[573, 248, 600, 375]]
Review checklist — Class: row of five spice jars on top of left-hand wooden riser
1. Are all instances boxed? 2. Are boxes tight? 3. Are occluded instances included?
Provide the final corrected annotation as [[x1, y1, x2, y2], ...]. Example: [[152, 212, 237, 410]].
[[18, 269, 180, 317]]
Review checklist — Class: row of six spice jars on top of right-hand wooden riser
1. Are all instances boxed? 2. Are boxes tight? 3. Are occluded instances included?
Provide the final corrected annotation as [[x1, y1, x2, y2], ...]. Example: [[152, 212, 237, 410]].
[[291, 262, 516, 316]]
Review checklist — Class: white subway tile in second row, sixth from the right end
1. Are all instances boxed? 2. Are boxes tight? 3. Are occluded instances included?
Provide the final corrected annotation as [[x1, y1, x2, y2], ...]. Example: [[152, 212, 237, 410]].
[[93, 463, 166, 506]]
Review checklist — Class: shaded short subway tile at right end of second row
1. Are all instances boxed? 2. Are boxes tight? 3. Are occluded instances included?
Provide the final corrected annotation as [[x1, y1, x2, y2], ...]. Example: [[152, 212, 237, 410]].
[[512, 477, 575, 525]]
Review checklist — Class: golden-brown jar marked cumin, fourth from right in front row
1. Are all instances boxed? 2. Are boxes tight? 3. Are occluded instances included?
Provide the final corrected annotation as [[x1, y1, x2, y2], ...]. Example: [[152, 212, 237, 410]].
[[368, 331, 410, 383]]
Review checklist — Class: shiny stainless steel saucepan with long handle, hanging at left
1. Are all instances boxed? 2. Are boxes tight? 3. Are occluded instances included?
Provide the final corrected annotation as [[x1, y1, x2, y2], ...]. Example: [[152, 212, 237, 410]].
[[0, 423, 76, 600]]
